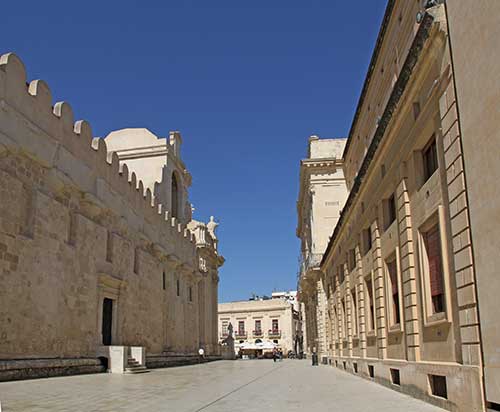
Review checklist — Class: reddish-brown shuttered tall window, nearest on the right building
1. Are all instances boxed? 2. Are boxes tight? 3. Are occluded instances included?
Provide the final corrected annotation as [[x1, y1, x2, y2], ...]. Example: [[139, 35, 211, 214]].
[[422, 224, 445, 313]]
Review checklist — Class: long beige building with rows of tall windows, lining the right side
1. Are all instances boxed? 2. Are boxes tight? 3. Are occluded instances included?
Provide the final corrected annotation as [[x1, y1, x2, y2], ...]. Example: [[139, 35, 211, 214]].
[[299, 0, 500, 412]]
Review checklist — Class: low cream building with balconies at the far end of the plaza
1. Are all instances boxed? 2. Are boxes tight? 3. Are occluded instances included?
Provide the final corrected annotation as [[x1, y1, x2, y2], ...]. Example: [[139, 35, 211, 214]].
[[219, 297, 301, 354]]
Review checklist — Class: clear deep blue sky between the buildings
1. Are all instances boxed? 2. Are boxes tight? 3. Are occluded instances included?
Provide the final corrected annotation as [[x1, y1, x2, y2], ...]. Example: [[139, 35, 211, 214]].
[[0, 0, 386, 301]]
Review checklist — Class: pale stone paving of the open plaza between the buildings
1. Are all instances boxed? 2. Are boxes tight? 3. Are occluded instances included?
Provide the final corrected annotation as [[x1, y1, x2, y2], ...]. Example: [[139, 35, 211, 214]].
[[0, 360, 443, 412]]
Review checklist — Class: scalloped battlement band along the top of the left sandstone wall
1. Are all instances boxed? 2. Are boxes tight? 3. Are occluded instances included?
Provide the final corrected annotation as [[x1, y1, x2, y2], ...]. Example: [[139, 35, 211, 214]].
[[0, 53, 221, 266]]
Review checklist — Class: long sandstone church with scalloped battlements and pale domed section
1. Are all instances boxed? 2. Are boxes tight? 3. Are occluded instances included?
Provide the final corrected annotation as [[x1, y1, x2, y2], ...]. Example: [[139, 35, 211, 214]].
[[0, 53, 224, 380]]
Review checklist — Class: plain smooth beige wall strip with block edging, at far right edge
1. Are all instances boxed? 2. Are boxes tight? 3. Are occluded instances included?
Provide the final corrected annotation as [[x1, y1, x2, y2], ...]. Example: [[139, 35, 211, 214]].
[[441, 0, 500, 408]]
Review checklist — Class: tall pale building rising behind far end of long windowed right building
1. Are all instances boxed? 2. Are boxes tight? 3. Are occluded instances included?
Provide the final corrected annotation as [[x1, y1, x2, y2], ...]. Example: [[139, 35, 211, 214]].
[[297, 136, 347, 357]]
